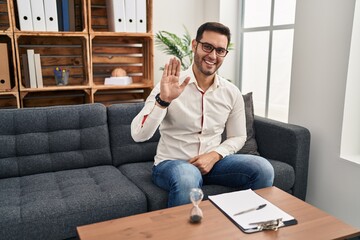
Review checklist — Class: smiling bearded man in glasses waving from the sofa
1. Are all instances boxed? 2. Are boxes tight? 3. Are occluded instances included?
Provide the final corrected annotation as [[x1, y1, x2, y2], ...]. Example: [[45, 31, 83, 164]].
[[131, 22, 274, 207]]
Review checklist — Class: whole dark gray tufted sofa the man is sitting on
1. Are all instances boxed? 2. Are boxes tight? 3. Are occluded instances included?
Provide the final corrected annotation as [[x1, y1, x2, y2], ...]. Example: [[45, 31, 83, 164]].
[[0, 103, 310, 240]]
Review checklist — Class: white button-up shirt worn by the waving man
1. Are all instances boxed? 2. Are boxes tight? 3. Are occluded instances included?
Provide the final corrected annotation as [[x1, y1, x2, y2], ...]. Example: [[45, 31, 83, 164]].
[[131, 67, 246, 165]]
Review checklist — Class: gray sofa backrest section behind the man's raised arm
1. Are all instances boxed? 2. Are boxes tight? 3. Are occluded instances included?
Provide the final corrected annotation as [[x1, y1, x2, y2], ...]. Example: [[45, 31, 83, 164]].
[[108, 103, 160, 166]]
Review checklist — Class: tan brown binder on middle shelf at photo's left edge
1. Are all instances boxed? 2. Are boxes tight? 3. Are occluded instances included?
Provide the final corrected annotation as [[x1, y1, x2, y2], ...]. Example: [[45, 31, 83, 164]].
[[0, 43, 11, 90]]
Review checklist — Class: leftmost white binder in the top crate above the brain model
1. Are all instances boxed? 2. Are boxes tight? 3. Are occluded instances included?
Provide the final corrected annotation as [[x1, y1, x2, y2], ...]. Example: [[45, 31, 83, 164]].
[[106, 0, 126, 32]]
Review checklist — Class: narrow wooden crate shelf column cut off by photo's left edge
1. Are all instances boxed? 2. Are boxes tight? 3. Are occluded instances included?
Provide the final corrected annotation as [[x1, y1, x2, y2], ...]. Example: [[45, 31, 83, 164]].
[[0, 0, 20, 108]]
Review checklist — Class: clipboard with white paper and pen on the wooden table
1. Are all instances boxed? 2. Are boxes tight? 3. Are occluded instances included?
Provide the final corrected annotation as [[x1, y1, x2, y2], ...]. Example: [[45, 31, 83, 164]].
[[208, 189, 297, 233]]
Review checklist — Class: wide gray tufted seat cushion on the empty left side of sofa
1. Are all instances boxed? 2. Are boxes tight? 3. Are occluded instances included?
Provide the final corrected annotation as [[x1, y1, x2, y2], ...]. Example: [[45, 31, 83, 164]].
[[0, 166, 147, 239]]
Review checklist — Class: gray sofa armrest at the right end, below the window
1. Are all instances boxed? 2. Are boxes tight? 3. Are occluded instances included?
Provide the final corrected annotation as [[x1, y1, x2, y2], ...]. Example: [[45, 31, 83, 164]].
[[254, 116, 310, 200]]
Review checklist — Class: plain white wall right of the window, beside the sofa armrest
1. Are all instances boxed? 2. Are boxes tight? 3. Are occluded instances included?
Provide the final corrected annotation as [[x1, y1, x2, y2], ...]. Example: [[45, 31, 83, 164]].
[[289, 0, 360, 227]]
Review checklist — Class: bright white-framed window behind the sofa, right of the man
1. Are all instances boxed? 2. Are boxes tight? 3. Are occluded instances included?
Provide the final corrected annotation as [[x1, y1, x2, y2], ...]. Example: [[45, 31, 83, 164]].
[[240, 0, 296, 122]]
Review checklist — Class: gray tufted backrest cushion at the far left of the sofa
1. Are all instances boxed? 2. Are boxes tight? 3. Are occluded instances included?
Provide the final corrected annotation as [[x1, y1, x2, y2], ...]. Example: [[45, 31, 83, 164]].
[[0, 104, 112, 178]]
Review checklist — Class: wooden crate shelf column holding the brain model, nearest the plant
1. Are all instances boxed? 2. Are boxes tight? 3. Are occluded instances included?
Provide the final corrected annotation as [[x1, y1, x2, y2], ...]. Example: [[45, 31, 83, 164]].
[[88, 0, 154, 104]]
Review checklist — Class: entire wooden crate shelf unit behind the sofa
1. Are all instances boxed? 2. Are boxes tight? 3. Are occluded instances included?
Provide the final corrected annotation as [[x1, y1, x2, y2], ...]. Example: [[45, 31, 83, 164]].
[[0, 0, 154, 108]]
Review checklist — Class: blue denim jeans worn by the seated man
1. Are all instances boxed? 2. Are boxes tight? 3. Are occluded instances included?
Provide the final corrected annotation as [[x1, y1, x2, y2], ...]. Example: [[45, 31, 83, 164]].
[[152, 154, 274, 207]]
